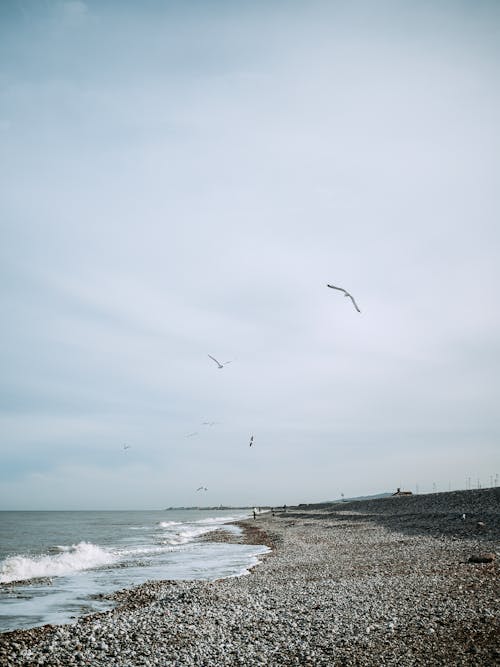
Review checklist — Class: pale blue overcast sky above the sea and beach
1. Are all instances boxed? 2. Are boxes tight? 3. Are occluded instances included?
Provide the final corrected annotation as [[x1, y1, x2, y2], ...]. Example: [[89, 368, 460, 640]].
[[0, 0, 500, 509]]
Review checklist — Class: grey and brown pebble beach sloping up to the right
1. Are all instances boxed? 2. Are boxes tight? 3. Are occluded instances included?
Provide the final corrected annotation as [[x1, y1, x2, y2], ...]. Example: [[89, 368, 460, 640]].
[[0, 489, 500, 667]]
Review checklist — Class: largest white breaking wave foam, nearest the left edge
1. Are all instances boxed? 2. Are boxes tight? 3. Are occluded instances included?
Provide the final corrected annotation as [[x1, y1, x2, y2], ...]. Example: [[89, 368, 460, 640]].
[[0, 542, 117, 584]]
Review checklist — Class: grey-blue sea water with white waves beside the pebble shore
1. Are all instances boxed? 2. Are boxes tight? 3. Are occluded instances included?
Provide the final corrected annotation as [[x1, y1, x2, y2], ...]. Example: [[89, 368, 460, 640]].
[[0, 510, 268, 632]]
